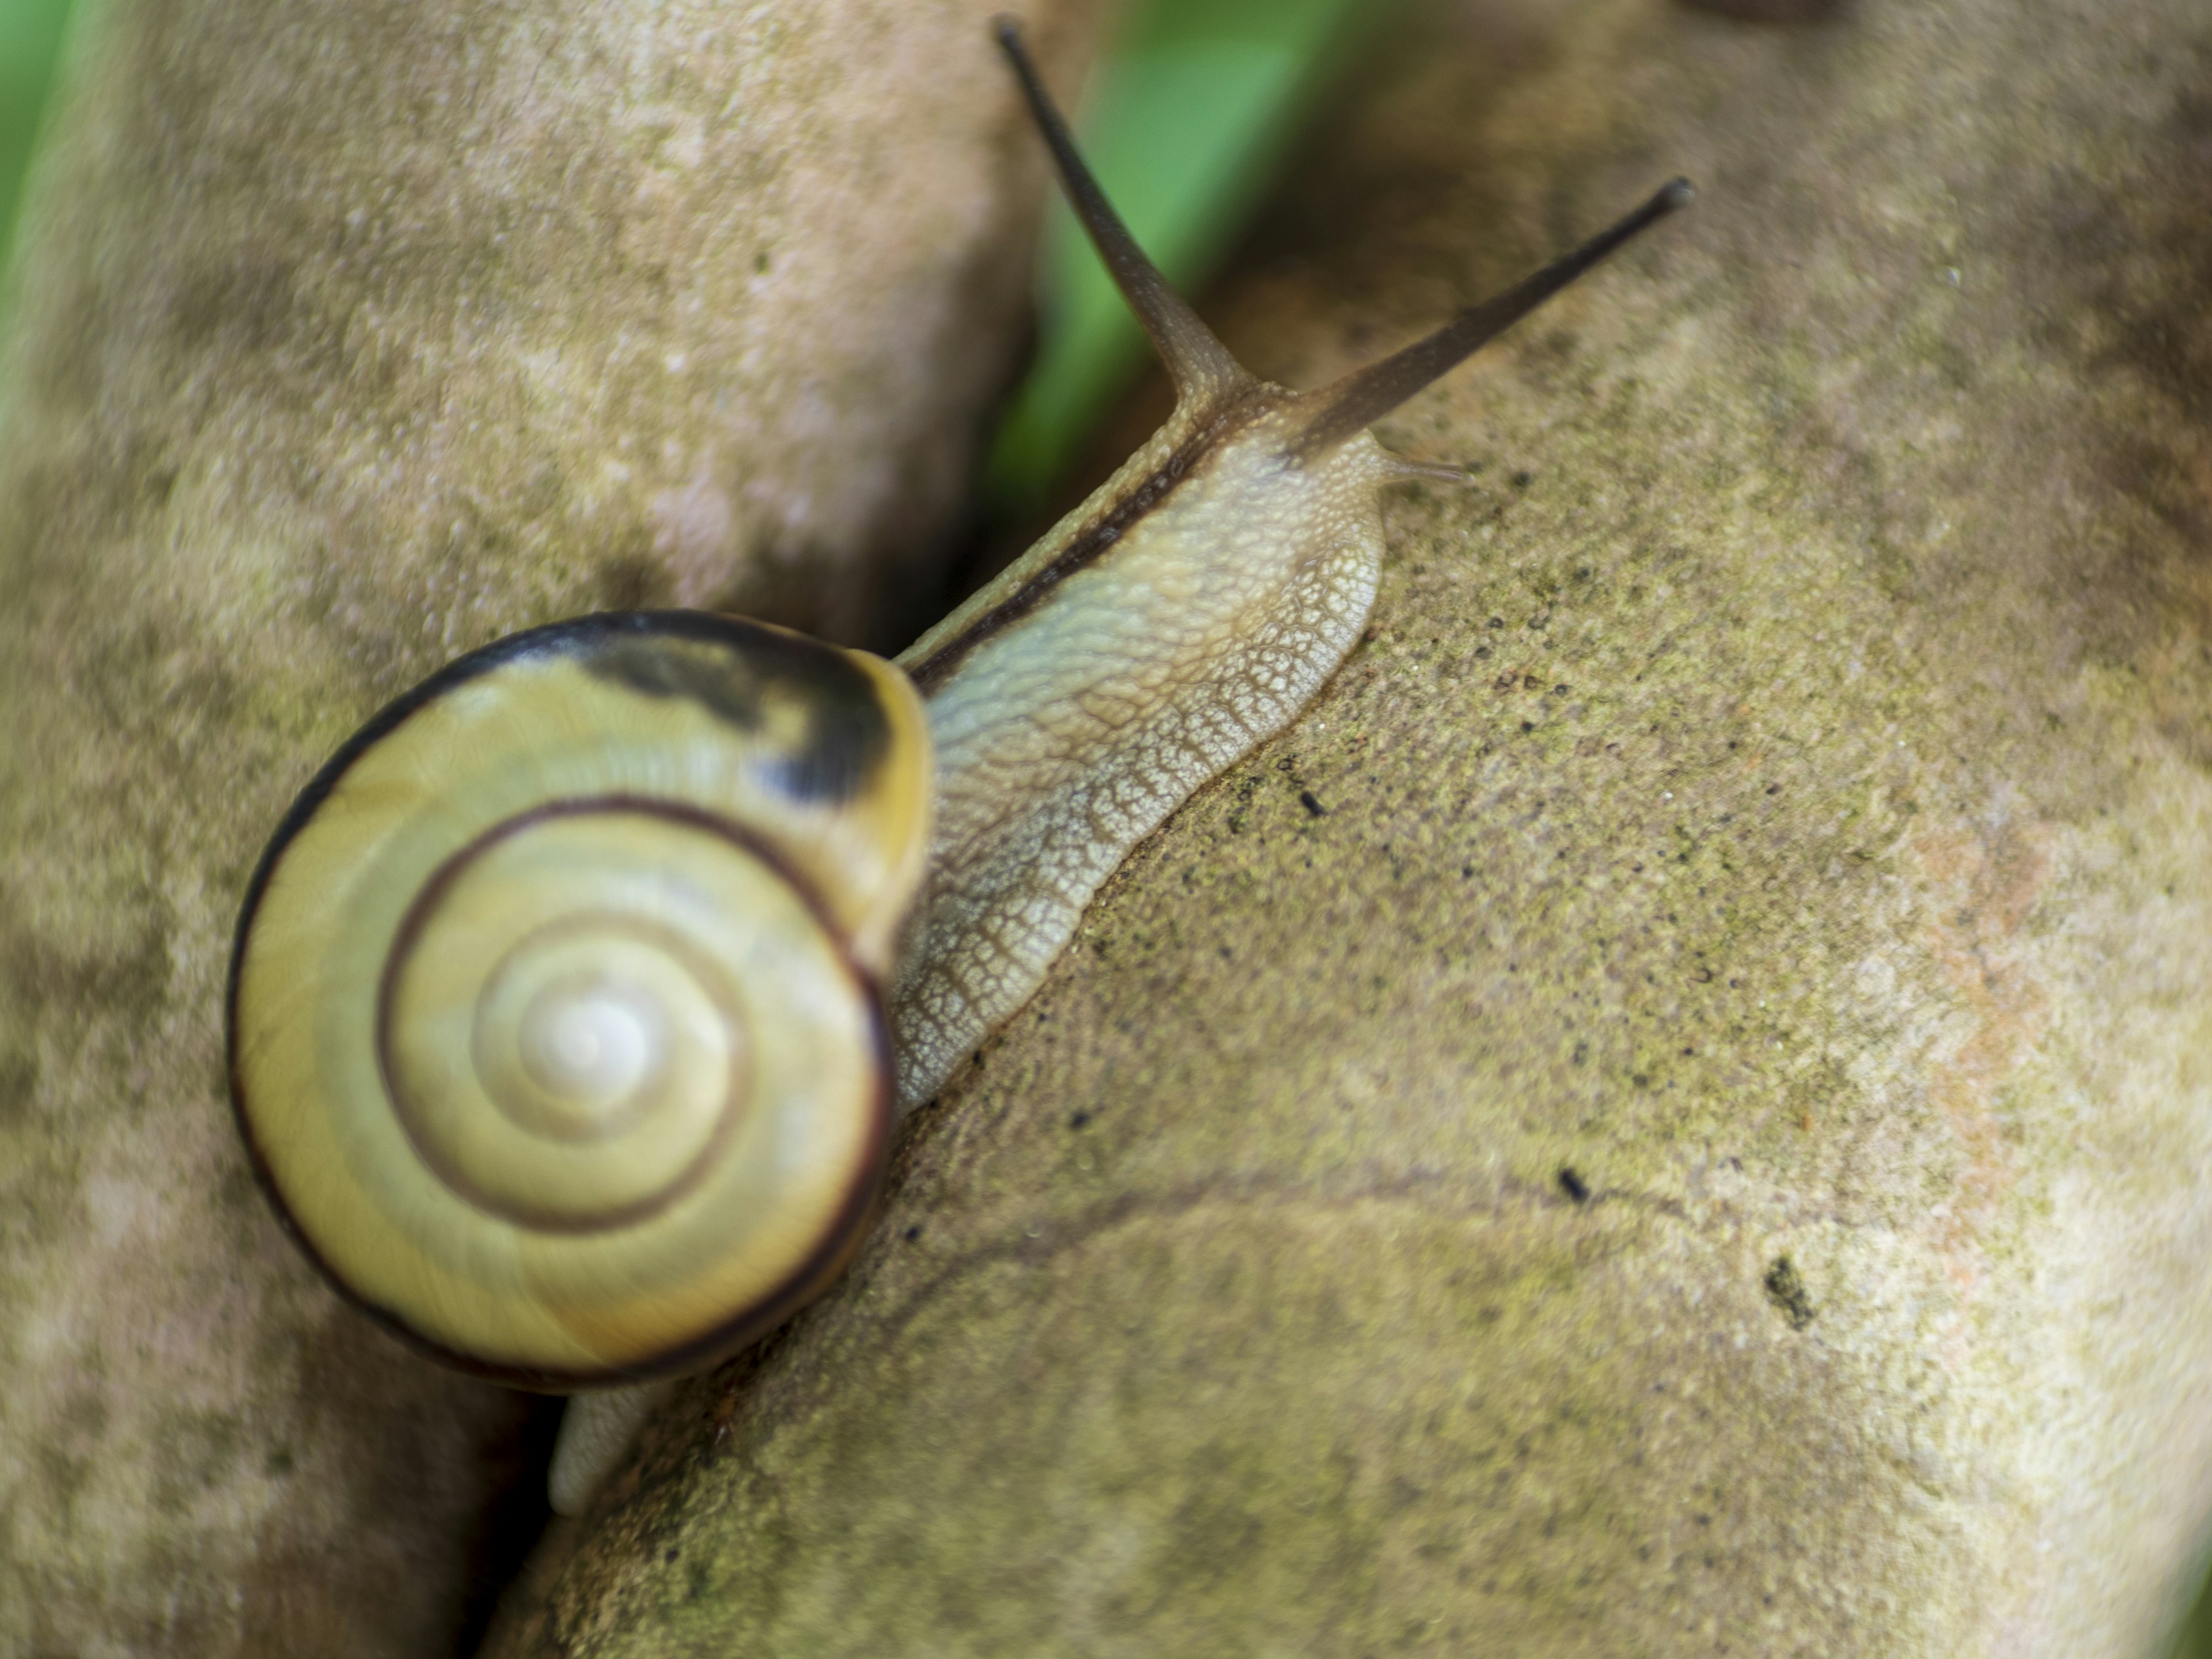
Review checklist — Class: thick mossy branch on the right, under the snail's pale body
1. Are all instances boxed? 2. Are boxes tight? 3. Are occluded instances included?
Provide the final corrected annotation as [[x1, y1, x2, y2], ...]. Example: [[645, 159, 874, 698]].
[[493, 0, 2212, 1659]]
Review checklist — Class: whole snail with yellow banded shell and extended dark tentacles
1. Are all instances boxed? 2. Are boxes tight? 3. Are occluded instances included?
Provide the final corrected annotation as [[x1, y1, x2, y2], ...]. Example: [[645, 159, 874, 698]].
[[228, 20, 1690, 1511]]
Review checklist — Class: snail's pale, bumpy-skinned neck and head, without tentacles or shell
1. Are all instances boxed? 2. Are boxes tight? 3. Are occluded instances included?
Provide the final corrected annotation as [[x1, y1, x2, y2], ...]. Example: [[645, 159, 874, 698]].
[[892, 402, 1407, 1108]]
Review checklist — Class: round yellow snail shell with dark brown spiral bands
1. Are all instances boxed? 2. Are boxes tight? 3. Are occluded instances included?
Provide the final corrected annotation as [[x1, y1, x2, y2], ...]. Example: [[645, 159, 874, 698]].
[[230, 613, 931, 1387]]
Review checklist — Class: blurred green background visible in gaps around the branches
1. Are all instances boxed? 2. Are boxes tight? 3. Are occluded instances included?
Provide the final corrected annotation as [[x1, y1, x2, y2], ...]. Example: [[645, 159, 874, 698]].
[[0, 0, 2212, 1659]]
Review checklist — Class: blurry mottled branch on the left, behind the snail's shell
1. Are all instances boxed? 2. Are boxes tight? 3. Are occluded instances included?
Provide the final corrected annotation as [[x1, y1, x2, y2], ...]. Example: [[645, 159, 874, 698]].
[[0, 0, 1090, 1657]]
